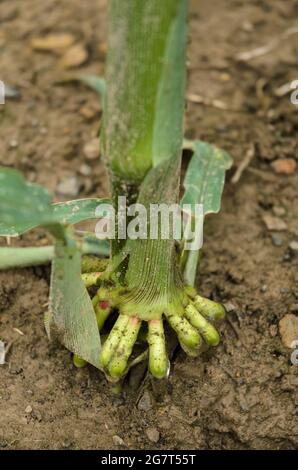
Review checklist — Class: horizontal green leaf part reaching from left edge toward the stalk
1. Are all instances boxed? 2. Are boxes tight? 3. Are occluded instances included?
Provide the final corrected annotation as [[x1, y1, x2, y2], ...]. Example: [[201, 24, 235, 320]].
[[0, 168, 109, 237]]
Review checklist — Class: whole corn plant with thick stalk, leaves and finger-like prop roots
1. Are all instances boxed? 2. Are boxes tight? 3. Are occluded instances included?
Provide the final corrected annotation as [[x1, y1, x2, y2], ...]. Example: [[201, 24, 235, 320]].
[[0, 0, 231, 381]]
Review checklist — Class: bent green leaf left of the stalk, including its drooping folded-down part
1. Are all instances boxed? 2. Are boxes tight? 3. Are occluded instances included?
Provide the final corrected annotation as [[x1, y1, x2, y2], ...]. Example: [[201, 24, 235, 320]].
[[0, 168, 107, 367]]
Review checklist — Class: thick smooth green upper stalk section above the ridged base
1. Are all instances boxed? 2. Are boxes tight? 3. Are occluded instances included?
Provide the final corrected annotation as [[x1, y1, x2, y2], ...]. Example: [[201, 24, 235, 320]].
[[102, 0, 188, 181]]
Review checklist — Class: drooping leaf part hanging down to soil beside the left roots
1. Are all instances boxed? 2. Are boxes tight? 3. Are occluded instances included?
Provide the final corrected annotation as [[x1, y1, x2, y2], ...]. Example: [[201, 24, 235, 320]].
[[45, 235, 101, 367]]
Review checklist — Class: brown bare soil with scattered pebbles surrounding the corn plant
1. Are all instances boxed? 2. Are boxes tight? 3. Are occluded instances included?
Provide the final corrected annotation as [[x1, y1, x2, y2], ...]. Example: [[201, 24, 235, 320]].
[[0, 0, 298, 449]]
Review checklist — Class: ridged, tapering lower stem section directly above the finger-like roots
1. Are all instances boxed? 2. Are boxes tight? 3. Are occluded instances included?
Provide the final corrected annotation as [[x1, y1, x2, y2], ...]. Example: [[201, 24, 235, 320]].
[[123, 156, 183, 318]]
